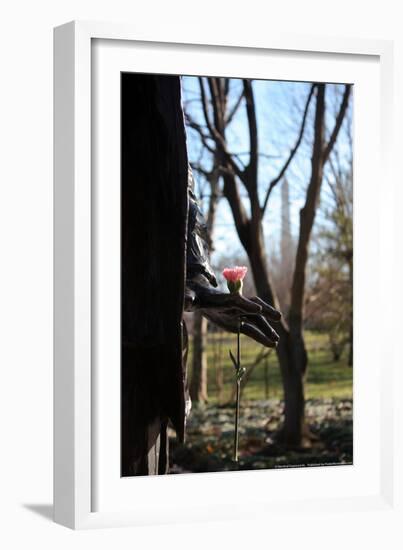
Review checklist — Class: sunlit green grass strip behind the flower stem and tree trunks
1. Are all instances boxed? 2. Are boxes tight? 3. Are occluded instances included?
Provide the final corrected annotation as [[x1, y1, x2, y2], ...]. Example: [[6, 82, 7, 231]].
[[188, 332, 353, 403]]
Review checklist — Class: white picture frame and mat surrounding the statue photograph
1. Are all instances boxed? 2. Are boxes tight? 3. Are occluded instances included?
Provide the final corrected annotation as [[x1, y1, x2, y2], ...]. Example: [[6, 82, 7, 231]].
[[54, 22, 398, 529]]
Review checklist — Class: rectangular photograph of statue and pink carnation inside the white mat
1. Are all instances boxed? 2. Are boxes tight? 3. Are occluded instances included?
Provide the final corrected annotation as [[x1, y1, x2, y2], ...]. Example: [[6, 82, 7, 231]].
[[120, 72, 354, 477]]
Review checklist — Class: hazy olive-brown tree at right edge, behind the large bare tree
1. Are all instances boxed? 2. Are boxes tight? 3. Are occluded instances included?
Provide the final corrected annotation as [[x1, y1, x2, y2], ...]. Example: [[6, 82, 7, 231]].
[[306, 125, 353, 366]]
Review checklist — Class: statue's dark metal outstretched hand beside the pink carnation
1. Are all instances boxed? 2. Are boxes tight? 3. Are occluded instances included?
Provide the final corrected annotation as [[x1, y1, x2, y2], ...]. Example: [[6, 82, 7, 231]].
[[185, 284, 281, 348]]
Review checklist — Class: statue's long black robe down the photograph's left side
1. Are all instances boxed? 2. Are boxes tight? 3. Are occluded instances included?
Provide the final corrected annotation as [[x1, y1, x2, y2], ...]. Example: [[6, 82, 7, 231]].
[[121, 73, 188, 476]]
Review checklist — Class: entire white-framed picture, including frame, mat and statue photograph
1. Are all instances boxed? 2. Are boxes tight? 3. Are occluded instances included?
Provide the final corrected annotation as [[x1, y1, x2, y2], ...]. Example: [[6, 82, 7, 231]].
[[54, 22, 396, 528]]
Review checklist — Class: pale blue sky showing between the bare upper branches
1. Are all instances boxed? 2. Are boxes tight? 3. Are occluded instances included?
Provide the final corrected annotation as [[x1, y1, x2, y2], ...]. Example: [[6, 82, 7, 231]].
[[182, 77, 351, 264]]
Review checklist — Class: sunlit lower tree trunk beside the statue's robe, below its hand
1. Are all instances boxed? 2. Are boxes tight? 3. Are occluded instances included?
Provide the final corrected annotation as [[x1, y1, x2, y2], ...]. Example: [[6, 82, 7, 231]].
[[189, 311, 208, 404]]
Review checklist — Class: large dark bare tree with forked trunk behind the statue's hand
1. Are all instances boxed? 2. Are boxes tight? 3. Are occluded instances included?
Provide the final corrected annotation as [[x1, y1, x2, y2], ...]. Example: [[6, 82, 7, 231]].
[[188, 78, 350, 446]]
